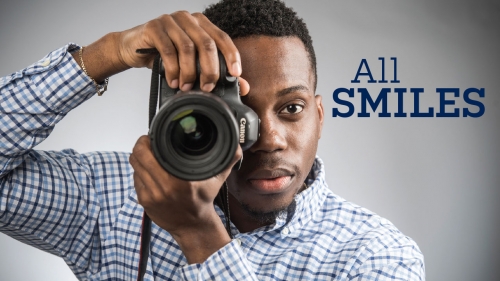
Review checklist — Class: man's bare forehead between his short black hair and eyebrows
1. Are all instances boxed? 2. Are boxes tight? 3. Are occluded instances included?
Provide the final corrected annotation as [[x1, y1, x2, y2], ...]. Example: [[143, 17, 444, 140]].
[[234, 36, 313, 93]]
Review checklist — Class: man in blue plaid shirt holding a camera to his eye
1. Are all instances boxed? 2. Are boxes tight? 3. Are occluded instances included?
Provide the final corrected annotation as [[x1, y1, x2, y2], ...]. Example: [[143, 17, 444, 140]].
[[0, 0, 424, 280]]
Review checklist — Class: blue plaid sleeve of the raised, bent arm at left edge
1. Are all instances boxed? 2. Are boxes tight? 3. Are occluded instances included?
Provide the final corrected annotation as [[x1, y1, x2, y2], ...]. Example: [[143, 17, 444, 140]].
[[0, 44, 100, 277]]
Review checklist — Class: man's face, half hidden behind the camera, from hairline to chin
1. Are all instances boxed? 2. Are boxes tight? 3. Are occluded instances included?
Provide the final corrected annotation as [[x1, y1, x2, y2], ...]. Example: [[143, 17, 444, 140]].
[[228, 36, 323, 221]]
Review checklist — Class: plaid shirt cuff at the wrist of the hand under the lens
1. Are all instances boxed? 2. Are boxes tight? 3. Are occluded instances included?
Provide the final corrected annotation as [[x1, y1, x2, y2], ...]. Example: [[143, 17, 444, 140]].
[[181, 239, 258, 281]]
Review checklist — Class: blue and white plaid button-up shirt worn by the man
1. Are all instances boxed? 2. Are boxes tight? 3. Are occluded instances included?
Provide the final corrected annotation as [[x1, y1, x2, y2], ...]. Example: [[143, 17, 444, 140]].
[[0, 44, 425, 280]]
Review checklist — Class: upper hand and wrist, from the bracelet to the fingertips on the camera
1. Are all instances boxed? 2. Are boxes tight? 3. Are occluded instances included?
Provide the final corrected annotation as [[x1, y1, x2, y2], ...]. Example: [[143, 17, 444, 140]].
[[73, 11, 250, 96]]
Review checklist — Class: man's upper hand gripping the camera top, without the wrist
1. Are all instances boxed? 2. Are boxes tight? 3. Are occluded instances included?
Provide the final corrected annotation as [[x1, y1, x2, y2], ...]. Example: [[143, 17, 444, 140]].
[[118, 11, 248, 94]]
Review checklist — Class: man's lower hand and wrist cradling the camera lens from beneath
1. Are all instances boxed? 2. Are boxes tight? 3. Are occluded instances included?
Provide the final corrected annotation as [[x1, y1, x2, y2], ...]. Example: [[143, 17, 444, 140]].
[[129, 136, 243, 263]]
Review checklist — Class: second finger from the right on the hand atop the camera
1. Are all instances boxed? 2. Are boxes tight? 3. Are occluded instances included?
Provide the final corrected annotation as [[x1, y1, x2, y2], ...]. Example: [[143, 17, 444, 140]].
[[174, 13, 219, 92]]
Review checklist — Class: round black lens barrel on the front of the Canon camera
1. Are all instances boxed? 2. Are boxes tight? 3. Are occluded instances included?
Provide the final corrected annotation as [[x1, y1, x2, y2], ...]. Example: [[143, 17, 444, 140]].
[[149, 91, 239, 181]]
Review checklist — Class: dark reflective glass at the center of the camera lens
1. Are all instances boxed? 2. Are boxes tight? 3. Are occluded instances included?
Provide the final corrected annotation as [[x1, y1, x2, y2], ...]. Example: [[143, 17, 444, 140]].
[[169, 111, 217, 156]]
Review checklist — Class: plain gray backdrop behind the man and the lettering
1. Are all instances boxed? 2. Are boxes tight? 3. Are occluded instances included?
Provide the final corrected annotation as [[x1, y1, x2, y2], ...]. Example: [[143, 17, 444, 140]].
[[0, 0, 500, 281]]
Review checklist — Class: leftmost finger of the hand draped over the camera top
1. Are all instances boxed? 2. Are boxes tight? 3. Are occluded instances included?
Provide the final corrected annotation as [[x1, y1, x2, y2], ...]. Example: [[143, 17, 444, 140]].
[[145, 15, 180, 89]]
